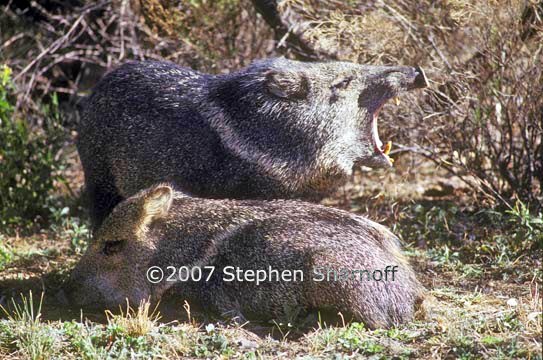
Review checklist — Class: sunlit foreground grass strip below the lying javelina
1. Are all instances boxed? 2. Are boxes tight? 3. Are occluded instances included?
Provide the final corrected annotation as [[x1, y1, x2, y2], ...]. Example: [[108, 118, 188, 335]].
[[0, 287, 541, 359]]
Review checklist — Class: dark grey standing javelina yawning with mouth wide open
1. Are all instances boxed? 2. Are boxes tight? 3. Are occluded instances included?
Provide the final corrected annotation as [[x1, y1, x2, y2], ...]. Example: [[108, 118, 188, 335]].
[[77, 58, 427, 228]]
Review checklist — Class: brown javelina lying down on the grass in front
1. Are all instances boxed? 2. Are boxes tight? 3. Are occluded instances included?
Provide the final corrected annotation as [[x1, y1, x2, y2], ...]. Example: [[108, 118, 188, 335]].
[[66, 185, 424, 328]]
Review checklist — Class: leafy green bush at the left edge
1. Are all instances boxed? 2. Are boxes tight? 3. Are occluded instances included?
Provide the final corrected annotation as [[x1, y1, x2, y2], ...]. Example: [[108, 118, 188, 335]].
[[0, 65, 65, 233]]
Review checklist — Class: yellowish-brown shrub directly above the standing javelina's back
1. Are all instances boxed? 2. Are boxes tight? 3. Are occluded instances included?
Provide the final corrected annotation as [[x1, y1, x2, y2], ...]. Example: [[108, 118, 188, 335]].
[[139, 0, 273, 72]]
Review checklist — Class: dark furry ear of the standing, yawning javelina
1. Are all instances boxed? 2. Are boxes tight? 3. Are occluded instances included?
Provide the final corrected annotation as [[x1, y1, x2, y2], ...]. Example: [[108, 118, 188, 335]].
[[266, 70, 309, 99]]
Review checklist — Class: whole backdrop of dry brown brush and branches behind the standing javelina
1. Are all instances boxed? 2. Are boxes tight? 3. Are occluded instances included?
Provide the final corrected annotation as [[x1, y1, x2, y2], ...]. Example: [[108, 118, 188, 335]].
[[0, 0, 543, 209]]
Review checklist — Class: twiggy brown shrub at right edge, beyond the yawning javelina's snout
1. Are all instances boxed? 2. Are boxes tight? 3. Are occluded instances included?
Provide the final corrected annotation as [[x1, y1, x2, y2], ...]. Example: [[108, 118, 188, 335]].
[[429, 5, 543, 208]]
